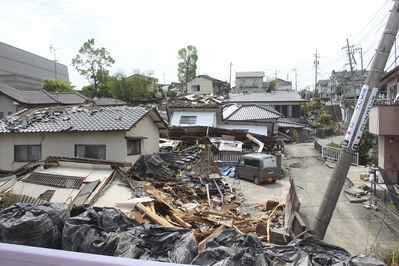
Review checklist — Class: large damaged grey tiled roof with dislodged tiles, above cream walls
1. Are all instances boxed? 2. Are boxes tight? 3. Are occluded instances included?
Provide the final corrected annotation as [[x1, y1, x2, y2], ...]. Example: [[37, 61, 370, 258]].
[[0, 106, 155, 133]]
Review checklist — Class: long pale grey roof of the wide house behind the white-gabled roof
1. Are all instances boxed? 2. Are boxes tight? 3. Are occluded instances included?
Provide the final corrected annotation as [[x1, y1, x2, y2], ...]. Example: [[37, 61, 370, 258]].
[[229, 91, 307, 103]]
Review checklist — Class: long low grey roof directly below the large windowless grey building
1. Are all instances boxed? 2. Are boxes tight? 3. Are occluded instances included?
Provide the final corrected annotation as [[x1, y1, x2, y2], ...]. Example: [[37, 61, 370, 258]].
[[0, 83, 90, 105]]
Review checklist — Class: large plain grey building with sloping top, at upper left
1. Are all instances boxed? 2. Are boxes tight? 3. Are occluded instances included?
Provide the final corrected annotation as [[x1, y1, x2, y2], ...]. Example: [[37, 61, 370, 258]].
[[0, 42, 69, 90]]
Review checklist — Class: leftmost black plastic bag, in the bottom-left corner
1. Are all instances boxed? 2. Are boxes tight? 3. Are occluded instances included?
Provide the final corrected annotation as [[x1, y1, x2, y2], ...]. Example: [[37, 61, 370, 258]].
[[0, 203, 69, 249]]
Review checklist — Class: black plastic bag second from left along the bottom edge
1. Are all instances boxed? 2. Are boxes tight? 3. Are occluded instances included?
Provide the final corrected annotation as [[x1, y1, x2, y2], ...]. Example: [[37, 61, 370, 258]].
[[62, 207, 140, 256]]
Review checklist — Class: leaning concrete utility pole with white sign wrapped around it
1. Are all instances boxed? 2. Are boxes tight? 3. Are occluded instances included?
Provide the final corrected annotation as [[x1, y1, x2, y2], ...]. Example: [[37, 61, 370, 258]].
[[313, 0, 399, 240]]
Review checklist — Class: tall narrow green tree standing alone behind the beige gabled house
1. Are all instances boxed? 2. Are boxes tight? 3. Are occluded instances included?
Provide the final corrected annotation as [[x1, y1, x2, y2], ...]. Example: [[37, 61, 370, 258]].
[[177, 45, 198, 92]]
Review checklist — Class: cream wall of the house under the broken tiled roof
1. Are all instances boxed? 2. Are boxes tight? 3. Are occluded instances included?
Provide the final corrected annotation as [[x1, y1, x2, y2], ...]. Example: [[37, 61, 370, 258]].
[[0, 117, 159, 170]]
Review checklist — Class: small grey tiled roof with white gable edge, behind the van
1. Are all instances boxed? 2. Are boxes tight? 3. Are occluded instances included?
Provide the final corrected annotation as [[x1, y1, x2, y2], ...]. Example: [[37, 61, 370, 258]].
[[223, 104, 283, 121]]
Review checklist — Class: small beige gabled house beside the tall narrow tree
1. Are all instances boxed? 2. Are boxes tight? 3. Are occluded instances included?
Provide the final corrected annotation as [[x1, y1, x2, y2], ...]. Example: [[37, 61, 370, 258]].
[[187, 75, 230, 96]]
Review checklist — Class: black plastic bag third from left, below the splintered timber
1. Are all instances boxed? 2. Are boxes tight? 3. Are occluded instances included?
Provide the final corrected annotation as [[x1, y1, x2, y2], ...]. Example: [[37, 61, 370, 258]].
[[129, 224, 198, 264]]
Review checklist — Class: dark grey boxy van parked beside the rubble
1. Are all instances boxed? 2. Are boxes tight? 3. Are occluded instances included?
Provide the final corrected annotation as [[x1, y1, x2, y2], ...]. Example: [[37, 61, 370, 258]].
[[235, 153, 280, 185]]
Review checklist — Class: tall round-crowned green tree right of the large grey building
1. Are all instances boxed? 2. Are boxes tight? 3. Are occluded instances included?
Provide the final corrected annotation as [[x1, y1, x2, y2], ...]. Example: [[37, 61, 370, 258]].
[[72, 39, 115, 97]]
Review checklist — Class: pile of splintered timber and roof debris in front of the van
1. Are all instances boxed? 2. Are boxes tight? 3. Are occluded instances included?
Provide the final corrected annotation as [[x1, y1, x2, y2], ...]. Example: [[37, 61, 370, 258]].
[[120, 145, 284, 247]]
